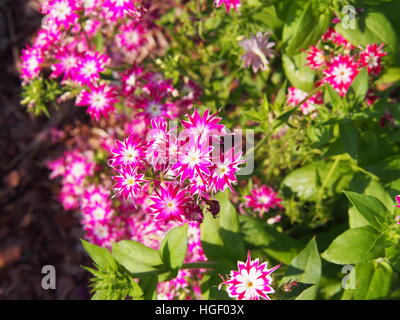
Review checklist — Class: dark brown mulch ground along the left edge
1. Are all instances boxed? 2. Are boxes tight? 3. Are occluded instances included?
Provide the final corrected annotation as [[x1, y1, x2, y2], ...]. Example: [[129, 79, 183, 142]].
[[0, 0, 90, 299]]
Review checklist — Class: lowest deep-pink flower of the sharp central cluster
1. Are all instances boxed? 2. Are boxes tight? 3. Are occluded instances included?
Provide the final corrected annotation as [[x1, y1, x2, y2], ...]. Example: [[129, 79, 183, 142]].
[[150, 183, 189, 222]]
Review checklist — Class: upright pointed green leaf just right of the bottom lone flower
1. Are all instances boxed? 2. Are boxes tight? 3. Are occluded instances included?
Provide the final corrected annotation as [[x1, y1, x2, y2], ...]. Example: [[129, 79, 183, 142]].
[[281, 237, 321, 300]]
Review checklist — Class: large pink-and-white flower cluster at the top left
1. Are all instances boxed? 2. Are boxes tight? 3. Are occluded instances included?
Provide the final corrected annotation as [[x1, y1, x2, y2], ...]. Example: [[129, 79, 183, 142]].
[[20, 0, 201, 121]]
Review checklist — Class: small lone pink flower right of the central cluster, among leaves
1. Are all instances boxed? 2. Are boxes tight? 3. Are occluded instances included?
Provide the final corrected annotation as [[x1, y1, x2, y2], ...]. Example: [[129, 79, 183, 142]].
[[244, 185, 283, 215]]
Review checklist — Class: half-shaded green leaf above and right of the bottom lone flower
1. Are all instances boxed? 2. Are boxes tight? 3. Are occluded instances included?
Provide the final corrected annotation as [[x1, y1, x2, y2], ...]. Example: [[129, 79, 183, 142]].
[[239, 215, 304, 264]]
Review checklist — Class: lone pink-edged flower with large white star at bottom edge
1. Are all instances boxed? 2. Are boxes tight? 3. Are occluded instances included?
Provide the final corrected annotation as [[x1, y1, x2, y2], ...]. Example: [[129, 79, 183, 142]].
[[221, 251, 280, 300]]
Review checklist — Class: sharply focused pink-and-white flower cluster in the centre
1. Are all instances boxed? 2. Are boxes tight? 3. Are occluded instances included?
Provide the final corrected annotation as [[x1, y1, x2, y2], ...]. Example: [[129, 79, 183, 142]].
[[109, 109, 243, 222]]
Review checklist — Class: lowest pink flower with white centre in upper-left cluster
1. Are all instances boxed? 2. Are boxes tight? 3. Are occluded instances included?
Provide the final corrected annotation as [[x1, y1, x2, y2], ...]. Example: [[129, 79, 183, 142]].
[[76, 84, 118, 121]]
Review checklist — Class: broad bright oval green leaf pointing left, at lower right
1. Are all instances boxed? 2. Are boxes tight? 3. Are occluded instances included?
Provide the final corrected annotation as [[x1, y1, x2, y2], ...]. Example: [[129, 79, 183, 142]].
[[322, 226, 387, 264]]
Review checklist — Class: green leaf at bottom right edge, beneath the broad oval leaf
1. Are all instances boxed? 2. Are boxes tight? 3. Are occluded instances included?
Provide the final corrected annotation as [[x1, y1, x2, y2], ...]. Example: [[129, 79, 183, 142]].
[[342, 259, 393, 300]]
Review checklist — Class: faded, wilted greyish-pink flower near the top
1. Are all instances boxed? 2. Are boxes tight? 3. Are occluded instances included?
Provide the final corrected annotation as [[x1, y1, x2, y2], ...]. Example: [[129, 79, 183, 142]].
[[239, 32, 275, 72]]
